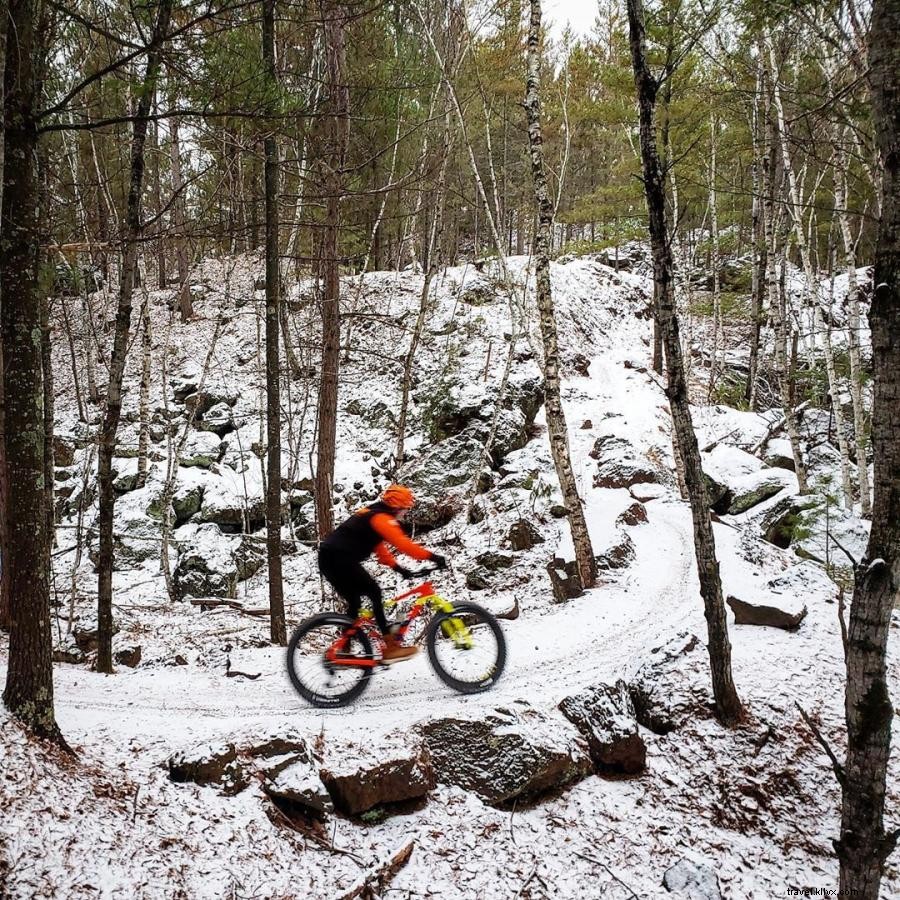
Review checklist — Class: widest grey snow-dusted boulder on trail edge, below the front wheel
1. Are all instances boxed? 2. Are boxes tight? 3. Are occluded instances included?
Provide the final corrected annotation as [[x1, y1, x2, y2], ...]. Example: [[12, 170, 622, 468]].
[[421, 703, 591, 806]]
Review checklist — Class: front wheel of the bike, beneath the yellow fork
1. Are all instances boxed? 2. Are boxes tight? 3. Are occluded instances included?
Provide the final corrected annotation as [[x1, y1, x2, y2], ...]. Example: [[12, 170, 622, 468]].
[[425, 603, 506, 694]]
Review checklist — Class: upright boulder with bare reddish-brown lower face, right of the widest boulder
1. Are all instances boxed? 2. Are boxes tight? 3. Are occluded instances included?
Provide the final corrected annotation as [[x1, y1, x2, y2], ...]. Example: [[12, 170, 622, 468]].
[[559, 679, 647, 775]]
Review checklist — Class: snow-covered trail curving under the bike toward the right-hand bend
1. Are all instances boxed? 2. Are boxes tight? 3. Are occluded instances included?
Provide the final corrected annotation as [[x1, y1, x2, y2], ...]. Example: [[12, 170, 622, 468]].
[[44, 501, 702, 762]]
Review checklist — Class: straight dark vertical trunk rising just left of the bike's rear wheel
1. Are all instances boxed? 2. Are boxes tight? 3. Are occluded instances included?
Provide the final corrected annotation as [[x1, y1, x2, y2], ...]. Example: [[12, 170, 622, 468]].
[[262, 0, 287, 644]]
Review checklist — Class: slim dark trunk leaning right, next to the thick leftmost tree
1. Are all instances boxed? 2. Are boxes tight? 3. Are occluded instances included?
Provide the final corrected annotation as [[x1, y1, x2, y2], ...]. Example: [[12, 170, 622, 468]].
[[97, 0, 172, 673]]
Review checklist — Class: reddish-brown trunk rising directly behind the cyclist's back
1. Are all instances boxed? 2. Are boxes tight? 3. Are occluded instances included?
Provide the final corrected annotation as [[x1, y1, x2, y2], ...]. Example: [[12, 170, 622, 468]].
[[316, 0, 350, 538]]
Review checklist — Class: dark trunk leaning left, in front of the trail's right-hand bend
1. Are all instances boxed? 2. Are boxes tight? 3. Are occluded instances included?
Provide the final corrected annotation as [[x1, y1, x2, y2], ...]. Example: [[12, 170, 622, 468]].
[[628, 0, 743, 725]]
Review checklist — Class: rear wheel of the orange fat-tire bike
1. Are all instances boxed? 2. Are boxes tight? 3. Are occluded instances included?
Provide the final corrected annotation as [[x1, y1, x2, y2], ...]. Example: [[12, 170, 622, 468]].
[[287, 613, 375, 709]]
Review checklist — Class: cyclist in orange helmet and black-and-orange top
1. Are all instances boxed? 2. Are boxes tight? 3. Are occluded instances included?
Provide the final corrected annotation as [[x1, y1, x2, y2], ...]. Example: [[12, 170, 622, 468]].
[[319, 484, 447, 662]]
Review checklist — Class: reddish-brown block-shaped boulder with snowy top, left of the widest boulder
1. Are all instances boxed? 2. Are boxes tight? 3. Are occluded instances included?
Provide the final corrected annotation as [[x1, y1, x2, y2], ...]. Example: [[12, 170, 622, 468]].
[[320, 743, 435, 816]]
